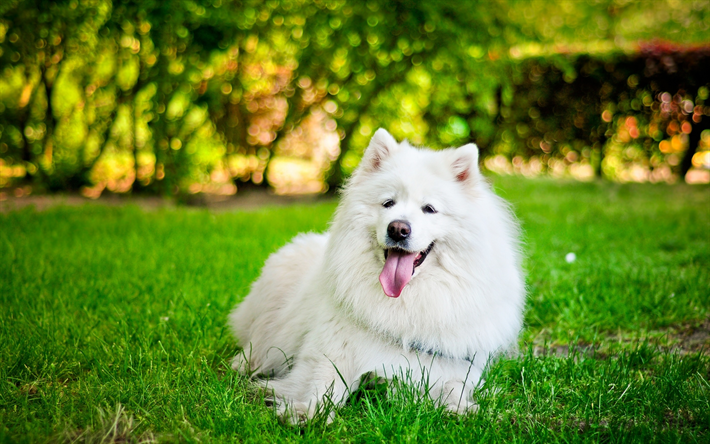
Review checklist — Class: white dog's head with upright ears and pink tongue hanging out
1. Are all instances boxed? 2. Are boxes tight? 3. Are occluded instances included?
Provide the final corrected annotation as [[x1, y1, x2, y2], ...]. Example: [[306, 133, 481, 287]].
[[345, 129, 481, 297]]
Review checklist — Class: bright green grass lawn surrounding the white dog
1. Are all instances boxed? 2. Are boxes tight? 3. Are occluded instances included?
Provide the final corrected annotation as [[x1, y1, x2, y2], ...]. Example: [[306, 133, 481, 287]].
[[0, 177, 710, 443]]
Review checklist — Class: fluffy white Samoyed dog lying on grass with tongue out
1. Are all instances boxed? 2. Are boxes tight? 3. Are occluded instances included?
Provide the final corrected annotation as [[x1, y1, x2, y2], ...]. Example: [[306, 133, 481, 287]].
[[229, 129, 525, 422]]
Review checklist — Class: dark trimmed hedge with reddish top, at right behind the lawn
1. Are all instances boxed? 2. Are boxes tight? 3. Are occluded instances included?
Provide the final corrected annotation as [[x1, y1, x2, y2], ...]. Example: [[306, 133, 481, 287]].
[[498, 44, 710, 181]]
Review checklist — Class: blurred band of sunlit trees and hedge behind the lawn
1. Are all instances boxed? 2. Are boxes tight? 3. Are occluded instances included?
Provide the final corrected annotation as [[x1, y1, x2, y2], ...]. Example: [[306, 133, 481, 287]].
[[0, 0, 710, 198]]
